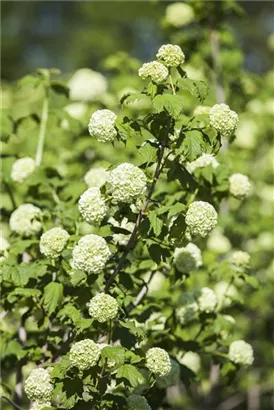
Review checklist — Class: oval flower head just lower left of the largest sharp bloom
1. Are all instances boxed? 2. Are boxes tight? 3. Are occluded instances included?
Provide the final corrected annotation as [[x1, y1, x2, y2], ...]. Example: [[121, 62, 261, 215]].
[[78, 187, 107, 224]]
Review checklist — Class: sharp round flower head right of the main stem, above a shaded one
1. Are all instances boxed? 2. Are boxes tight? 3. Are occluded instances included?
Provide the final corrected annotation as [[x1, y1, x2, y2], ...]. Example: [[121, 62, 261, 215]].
[[186, 201, 218, 237]]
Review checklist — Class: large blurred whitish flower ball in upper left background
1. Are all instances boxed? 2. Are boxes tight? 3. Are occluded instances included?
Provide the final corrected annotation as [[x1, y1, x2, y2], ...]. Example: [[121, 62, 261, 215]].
[[68, 68, 107, 101]]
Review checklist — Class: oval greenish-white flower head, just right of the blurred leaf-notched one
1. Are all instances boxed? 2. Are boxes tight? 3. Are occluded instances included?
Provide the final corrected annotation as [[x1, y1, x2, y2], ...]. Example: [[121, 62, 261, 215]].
[[39, 228, 69, 259]]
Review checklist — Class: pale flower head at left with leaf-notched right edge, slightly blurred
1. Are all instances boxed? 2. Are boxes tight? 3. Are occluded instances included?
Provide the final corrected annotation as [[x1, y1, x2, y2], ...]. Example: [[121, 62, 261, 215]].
[[10, 204, 42, 237]]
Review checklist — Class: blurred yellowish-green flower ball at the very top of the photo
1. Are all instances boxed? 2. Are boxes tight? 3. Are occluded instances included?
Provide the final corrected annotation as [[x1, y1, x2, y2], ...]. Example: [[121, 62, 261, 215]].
[[166, 2, 194, 28]]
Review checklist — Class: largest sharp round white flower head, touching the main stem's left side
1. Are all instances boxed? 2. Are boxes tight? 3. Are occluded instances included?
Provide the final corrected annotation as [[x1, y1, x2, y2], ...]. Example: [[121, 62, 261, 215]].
[[108, 162, 147, 203]]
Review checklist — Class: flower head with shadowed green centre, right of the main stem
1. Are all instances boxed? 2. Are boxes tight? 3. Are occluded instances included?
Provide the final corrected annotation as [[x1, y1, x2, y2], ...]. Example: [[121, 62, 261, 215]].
[[174, 243, 203, 272]]
